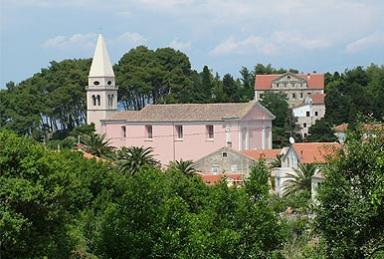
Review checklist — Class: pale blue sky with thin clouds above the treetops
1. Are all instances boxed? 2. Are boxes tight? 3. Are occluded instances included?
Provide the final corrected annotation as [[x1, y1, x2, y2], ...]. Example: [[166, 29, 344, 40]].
[[0, 0, 384, 87]]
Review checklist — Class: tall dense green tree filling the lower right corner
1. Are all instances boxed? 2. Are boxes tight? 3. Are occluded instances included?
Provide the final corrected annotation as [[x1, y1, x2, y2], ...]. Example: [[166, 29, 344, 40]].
[[316, 123, 384, 258]]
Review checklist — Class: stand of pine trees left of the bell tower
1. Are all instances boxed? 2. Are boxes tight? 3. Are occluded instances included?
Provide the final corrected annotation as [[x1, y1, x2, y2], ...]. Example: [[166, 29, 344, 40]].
[[0, 59, 90, 136]]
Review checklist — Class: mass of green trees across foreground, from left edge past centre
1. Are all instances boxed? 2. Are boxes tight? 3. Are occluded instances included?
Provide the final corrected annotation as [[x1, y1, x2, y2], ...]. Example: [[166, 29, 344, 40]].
[[0, 131, 282, 258]]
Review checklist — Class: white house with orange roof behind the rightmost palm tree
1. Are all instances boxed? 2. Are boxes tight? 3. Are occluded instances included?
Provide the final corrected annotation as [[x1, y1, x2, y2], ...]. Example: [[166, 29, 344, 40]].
[[272, 142, 341, 196]]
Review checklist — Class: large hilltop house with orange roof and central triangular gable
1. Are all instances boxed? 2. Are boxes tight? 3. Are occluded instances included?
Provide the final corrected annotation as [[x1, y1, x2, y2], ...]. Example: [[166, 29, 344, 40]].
[[255, 72, 324, 108]]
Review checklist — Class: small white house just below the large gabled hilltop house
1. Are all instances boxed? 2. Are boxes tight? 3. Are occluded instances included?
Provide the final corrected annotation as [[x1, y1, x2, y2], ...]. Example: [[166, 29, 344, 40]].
[[292, 94, 325, 138]]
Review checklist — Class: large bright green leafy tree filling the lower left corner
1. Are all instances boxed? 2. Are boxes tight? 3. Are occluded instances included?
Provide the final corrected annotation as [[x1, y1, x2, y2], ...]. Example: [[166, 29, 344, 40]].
[[0, 131, 121, 258]]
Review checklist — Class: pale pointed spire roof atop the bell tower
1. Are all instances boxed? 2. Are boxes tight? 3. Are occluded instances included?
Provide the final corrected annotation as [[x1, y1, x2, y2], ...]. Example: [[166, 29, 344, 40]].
[[88, 34, 115, 77]]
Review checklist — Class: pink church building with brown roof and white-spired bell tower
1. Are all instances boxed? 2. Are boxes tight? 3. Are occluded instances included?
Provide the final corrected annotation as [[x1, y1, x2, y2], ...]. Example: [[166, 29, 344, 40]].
[[87, 35, 274, 165]]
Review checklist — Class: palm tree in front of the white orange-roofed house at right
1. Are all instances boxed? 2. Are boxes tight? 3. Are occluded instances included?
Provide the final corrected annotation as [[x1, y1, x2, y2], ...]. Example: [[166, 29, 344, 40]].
[[283, 164, 317, 196]]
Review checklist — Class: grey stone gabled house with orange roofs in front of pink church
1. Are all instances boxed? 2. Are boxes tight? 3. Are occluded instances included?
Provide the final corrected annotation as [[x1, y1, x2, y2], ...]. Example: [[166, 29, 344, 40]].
[[194, 147, 281, 185]]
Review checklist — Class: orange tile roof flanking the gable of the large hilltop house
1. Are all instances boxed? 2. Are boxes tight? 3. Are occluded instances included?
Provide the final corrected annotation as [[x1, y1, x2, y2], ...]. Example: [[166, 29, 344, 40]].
[[255, 73, 324, 90]]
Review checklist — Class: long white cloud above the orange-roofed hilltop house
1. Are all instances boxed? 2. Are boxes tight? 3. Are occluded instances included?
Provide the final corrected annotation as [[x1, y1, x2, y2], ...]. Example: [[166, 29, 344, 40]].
[[210, 31, 331, 55]]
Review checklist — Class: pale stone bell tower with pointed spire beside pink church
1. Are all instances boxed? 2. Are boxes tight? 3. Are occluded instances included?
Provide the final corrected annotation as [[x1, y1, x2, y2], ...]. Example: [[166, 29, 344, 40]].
[[86, 34, 117, 133]]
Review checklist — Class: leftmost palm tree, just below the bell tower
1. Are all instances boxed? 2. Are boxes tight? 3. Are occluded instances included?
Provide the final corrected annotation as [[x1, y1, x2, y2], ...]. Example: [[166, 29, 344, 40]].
[[82, 133, 113, 157]]
